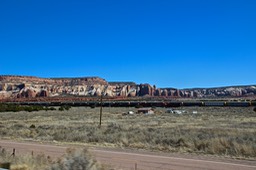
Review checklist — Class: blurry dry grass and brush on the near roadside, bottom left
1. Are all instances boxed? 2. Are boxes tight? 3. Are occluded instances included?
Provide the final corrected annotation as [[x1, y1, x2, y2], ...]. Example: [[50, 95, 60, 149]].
[[0, 148, 103, 170]]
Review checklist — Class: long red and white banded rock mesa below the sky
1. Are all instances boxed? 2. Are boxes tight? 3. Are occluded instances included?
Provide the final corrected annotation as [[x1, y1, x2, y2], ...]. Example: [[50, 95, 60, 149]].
[[0, 75, 256, 99]]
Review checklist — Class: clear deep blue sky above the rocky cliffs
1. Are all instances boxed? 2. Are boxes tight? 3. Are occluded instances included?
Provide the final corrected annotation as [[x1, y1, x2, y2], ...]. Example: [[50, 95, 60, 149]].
[[0, 0, 256, 88]]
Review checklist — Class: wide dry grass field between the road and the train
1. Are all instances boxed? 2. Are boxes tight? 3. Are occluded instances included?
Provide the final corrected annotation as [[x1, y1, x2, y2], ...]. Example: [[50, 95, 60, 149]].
[[0, 107, 256, 159]]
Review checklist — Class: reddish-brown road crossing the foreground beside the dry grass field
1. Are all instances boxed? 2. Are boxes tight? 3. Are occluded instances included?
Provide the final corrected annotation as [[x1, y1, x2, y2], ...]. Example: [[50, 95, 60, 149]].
[[0, 140, 256, 170]]
